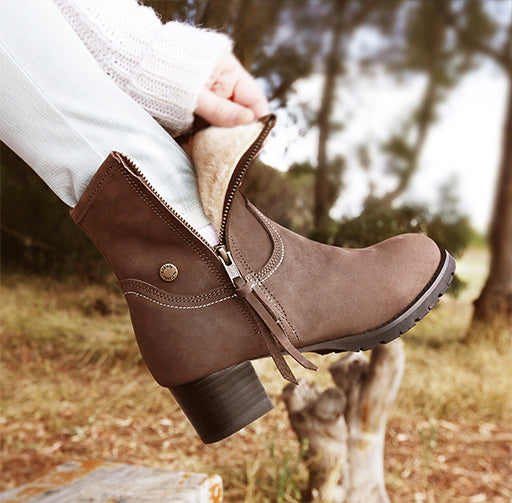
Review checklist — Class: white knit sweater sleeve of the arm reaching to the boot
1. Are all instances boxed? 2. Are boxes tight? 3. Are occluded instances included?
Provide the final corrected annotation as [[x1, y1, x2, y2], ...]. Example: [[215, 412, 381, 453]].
[[53, 0, 231, 134]]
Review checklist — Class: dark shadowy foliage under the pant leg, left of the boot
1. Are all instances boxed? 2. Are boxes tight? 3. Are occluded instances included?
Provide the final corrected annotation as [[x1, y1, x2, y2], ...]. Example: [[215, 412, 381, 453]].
[[0, 144, 107, 279]]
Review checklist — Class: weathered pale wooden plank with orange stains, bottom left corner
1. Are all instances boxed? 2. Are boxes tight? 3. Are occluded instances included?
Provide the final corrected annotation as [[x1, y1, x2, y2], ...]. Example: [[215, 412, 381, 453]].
[[0, 461, 222, 503]]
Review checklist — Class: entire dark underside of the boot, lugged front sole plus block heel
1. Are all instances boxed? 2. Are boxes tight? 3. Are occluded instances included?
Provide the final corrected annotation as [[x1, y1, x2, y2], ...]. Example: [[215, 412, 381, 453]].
[[169, 251, 455, 444]]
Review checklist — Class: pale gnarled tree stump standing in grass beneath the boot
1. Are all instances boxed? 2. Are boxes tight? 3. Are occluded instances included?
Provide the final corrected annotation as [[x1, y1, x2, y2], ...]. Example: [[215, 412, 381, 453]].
[[283, 340, 405, 503]]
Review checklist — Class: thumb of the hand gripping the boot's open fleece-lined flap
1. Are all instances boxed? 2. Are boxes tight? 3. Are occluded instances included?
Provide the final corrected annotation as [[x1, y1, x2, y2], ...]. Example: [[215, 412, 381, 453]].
[[195, 89, 254, 127]]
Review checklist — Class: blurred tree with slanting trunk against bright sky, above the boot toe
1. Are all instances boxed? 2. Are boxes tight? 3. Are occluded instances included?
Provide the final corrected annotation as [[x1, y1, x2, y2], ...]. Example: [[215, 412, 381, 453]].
[[365, 0, 452, 212]]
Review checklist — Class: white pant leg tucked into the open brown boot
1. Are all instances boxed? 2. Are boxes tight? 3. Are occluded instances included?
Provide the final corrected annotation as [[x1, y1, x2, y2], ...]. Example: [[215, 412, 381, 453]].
[[0, 0, 212, 234]]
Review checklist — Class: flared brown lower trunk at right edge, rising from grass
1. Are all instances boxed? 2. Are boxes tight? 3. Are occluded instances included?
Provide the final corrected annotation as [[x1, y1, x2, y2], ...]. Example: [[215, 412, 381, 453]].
[[468, 76, 512, 339]]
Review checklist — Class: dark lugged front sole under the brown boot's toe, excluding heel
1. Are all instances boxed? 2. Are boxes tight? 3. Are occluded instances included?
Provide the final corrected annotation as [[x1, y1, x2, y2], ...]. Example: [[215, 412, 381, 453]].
[[300, 250, 455, 355]]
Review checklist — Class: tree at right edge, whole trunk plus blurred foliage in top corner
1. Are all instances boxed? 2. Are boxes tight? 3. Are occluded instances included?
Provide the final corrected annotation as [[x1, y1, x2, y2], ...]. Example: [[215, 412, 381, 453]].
[[442, 0, 512, 340]]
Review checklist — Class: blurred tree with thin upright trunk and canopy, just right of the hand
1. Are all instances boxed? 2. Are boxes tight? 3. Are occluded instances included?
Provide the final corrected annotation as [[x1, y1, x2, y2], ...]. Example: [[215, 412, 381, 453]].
[[147, 0, 403, 241]]
